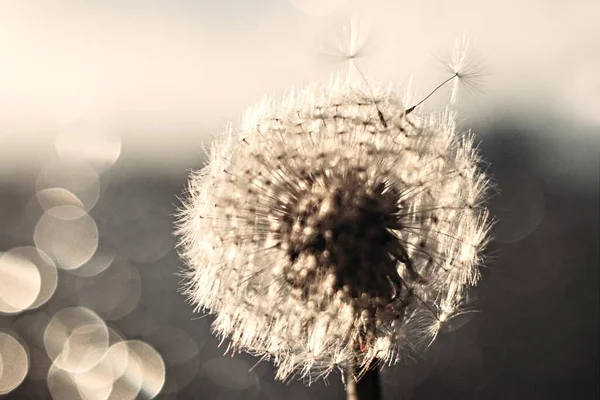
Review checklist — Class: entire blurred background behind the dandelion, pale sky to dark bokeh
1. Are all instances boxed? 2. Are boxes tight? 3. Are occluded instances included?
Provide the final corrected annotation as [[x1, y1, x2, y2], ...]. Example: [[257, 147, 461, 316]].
[[0, 0, 600, 400]]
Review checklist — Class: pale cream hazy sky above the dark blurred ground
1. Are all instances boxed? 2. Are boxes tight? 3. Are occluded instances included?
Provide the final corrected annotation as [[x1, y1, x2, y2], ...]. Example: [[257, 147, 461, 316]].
[[0, 0, 600, 170]]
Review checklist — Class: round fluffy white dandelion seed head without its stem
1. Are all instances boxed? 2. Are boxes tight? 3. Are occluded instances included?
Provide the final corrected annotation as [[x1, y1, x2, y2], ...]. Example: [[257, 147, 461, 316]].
[[177, 72, 488, 380]]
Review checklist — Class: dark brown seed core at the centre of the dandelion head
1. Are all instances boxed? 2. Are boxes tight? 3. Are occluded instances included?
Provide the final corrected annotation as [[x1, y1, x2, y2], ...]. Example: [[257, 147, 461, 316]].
[[278, 167, 409, 306]]
